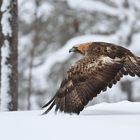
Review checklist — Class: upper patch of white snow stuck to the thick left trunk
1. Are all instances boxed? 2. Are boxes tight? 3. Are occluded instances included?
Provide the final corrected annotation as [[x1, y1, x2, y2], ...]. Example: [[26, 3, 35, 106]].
[[1, 0, 12, 36]]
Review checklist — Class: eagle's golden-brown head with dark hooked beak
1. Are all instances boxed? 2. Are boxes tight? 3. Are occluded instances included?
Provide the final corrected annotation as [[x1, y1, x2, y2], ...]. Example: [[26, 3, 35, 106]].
[[69, 42, 92, 55]]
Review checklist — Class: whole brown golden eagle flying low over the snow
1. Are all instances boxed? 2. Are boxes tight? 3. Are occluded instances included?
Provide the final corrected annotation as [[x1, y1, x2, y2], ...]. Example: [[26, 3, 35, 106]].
[[43, 42, 140, 114]]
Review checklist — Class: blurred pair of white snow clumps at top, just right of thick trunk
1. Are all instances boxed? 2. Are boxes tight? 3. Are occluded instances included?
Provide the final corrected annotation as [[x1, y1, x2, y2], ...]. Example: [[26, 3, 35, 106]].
[[18, 0, 54, 24]]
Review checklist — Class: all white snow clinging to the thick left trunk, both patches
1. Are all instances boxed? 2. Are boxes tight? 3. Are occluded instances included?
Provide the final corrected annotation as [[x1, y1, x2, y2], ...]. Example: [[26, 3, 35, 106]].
[[0, 0, 12, 111]]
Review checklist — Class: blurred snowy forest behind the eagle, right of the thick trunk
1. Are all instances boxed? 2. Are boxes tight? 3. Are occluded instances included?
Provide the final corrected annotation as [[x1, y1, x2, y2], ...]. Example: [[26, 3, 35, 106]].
[[18, 0, 140, 110]]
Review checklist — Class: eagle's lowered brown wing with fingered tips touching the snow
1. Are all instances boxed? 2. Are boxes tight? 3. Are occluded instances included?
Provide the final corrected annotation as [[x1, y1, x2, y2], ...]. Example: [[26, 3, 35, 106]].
[[44, 56, 123, 114]]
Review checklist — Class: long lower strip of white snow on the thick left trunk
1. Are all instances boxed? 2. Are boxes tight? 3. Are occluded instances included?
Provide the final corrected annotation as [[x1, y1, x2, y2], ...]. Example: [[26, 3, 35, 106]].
[[0, 40, 11, 111]]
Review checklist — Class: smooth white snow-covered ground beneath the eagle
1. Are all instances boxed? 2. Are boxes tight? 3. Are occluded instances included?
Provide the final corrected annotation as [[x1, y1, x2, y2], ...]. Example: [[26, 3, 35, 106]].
[[0, 101, 140, 140]]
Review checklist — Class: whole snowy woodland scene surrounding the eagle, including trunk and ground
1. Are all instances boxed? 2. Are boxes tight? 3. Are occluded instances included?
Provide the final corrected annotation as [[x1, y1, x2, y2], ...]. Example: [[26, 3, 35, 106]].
[[0, 0, 140, 140]]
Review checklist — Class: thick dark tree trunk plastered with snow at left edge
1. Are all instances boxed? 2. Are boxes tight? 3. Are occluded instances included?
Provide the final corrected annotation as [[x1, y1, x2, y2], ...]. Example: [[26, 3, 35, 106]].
[[1, 0, 18, 111]]
